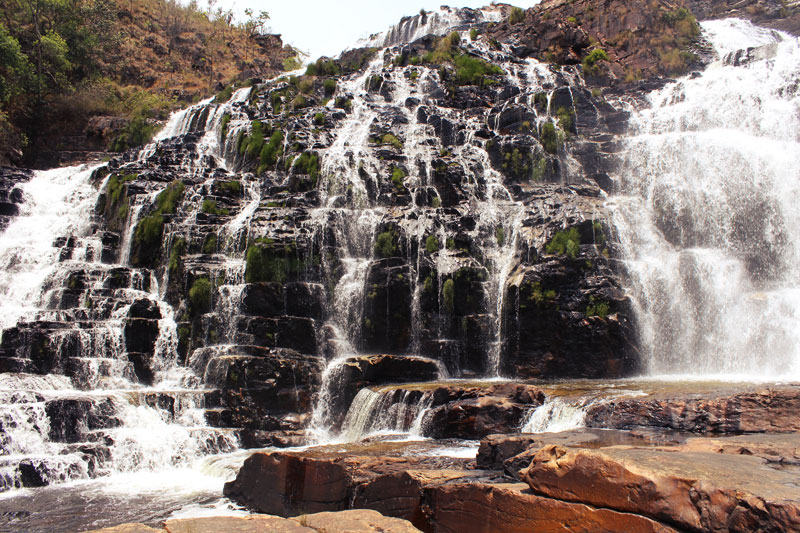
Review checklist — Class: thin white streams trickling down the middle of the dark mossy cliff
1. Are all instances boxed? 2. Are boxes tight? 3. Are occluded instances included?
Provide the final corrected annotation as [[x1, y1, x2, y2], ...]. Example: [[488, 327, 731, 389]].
[[310, 14, 572, 442]]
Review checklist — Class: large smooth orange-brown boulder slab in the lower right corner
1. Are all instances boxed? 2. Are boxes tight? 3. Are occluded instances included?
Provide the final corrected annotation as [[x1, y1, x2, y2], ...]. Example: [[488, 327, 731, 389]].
[[522, 441, 800, 532]]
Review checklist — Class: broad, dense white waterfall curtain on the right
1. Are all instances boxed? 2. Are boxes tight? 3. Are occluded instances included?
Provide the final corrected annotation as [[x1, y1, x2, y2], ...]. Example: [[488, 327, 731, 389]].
[[609, 20, 800, 380]]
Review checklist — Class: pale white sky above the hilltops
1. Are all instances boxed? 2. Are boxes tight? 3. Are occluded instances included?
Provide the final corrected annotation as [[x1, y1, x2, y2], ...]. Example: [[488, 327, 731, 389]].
[[212, 0, 539, 60]]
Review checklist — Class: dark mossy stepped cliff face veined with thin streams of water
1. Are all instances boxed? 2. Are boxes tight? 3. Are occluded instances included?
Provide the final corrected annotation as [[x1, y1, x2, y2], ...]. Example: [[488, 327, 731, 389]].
[[0, 0, 796, 494]]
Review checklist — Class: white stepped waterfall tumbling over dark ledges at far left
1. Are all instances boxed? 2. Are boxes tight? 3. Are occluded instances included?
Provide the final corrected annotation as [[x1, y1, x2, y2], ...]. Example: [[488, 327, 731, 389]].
[[0, 88, 255, 492]]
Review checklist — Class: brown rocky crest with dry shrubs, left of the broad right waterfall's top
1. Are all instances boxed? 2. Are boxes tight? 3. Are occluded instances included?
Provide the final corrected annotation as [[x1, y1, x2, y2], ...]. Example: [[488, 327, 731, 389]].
[[489, 0, 702, 85]]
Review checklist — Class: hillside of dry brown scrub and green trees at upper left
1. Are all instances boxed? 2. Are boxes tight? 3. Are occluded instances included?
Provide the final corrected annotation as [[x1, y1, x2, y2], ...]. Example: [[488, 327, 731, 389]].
[[0, 0, 297, 165]]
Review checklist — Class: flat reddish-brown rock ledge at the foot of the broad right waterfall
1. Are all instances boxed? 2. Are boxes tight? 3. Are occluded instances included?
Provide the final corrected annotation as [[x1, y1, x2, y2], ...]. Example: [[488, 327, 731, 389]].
[[586, 385, 800, 433]]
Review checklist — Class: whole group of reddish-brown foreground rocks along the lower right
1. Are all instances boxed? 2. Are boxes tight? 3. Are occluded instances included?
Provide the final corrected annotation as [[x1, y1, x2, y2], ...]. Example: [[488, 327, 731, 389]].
[[225, 430, 800, 532]]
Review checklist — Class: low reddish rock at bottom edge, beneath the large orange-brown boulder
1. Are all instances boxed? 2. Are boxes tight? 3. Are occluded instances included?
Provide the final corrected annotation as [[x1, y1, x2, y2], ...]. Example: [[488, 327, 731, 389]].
[[426, 483, 675, 533]]
